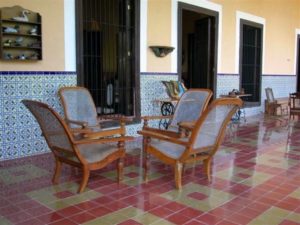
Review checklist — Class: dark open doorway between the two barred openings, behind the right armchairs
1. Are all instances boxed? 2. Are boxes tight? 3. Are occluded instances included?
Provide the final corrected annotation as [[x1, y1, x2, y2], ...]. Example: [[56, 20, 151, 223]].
[[178, 3, 218, 97]]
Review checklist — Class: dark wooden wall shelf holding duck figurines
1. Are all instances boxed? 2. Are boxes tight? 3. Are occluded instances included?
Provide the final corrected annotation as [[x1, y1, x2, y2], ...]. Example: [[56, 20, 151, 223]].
[[0, 6, 42, 61]]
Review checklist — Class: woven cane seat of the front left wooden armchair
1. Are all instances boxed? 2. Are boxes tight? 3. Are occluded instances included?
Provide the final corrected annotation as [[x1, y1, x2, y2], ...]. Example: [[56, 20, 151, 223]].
[[77, 144, 118, 163]]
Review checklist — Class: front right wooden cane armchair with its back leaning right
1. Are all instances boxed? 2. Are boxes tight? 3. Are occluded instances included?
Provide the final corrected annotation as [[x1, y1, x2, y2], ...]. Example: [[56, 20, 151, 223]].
[[138, 98, 242, 189]]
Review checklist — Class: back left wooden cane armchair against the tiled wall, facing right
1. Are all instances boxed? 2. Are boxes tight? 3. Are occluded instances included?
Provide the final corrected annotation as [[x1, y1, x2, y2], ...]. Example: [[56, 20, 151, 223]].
[[58, 87, 131, 138]]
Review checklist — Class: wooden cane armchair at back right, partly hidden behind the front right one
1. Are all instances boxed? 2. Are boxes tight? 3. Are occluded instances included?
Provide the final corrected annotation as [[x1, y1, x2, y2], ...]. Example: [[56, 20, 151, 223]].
[[142, 89, 212, 136]]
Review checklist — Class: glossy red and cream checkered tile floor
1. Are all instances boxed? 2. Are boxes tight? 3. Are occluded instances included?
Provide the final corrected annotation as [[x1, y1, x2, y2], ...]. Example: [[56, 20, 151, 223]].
[[0, 117, 300, 225]]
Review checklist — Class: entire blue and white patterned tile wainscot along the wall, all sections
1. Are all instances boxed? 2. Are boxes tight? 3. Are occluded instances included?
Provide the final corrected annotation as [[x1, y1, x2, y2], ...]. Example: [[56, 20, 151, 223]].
[[0, 71, 296, 161]]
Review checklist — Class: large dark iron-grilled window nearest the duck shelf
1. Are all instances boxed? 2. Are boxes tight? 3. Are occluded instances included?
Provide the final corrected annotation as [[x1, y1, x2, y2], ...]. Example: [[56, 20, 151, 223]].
[[76, 0, 140, 116]]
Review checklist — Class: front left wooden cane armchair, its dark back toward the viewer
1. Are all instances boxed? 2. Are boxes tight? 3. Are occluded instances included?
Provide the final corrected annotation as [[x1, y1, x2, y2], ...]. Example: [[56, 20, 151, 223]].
[[22, 100, 133, 193]]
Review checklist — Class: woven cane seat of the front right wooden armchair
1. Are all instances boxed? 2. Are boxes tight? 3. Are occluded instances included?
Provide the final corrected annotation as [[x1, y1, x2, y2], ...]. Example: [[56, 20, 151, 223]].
[[150, 138, 185, 159]]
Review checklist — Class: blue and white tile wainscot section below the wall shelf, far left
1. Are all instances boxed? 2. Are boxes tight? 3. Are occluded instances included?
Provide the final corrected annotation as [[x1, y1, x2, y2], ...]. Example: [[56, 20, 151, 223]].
[[0, 71, 77, 161]]
